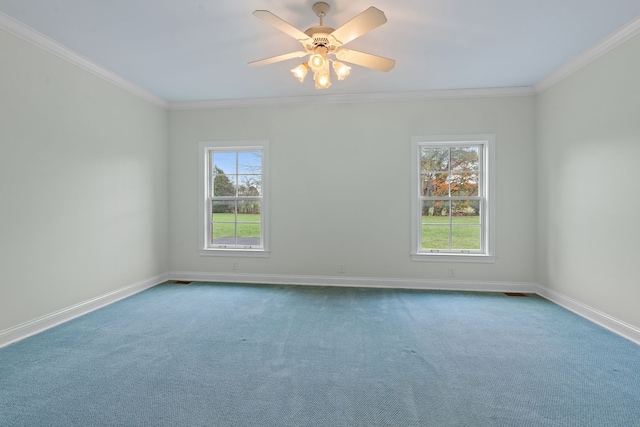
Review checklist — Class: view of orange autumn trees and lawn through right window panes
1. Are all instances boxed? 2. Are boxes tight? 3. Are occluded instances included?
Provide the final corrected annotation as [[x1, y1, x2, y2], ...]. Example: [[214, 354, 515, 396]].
[[420, 145, 482, 252]]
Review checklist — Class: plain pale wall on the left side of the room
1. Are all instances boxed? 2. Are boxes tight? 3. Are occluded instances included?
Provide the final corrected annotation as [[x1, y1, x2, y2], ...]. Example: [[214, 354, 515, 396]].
[[0, 30, 168, 331]]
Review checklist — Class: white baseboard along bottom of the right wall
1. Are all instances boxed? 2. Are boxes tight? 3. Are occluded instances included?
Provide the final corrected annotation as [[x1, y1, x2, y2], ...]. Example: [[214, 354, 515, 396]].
[[536, 285, 640, 345]]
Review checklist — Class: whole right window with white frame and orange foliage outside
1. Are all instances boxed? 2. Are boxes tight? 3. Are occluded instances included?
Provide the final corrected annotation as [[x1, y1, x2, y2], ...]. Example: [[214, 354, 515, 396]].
[[411, 135, 495, 262]]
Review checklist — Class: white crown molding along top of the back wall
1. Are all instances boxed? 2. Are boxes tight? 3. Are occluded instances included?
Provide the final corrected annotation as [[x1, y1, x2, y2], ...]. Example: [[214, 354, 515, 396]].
[[169, 86, 535, 110]]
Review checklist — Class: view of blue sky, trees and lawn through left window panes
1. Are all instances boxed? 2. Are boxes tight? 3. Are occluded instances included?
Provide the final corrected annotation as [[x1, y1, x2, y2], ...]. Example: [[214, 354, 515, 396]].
[[209, 151, 263, 247]]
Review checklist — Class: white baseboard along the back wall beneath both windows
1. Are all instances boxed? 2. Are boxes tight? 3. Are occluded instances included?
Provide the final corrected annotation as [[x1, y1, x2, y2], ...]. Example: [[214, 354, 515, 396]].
[[169, 271, 538, 293]]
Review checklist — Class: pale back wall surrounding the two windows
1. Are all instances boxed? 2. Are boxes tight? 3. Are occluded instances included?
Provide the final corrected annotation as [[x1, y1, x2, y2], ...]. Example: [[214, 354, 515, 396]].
[[169, 97, 535, 288]]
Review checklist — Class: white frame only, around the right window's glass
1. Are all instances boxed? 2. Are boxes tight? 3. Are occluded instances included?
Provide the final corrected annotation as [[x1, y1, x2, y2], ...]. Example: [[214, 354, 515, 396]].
[[410, 134, 496, 263]]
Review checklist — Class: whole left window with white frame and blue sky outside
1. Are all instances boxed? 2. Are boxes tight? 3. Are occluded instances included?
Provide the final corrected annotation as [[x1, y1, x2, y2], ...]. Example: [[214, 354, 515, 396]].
[[200, 141, 268, 256]]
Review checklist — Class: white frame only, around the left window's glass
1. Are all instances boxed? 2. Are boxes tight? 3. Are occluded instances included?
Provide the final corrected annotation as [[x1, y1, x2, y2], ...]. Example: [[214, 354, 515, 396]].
[[198, 140, 269, 257]]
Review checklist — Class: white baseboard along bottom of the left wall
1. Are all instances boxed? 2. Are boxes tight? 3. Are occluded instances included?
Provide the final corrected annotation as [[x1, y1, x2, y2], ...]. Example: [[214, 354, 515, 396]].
[[0, 273, 169, 348]]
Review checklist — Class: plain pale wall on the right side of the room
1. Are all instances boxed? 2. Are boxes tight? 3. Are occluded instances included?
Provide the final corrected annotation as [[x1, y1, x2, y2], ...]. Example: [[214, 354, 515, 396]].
[[537, 36, 640, 328]]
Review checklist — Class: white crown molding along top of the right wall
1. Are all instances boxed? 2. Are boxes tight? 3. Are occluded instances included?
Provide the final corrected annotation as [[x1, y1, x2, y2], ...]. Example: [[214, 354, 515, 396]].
[[533, 16, 640, 94]]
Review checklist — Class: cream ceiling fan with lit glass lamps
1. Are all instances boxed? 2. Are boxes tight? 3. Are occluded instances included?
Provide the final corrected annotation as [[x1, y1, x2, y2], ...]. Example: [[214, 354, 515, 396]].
[[249, 2, 396, 89]]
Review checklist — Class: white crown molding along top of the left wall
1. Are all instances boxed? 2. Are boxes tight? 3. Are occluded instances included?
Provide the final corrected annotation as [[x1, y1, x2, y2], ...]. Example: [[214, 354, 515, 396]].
[[0, 12, 169, 108]]
